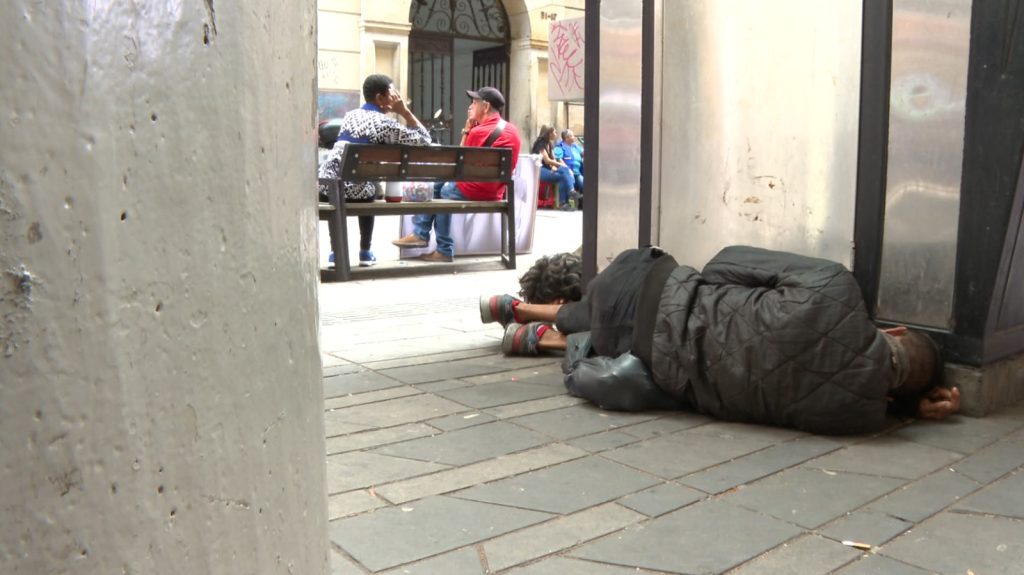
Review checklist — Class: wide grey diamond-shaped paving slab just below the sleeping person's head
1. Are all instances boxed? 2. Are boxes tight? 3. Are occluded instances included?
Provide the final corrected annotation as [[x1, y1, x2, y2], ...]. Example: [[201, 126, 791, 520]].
[[804, 436, 963, 479]]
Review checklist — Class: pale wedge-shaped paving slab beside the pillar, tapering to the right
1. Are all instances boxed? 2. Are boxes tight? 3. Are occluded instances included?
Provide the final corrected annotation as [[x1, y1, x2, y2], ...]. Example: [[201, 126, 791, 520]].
[[327, 451, 449, 493]]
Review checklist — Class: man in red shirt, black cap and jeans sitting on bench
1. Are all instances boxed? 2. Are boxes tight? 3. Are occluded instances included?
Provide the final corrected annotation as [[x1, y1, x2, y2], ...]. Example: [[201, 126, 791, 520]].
[[392, 86, 521, 262]]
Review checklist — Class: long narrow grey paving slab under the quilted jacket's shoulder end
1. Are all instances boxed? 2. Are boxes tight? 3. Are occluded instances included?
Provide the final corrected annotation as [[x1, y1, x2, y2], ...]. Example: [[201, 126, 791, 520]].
[[679, 436, 841, 493]]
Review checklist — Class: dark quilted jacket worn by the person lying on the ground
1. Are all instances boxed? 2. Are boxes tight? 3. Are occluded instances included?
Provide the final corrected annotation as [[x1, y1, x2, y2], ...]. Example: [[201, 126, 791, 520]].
[[651, 247, 894, 434]]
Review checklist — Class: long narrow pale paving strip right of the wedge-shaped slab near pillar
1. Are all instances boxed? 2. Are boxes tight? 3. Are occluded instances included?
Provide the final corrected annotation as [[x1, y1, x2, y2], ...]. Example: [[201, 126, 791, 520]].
[[377, 443, 587, 503]]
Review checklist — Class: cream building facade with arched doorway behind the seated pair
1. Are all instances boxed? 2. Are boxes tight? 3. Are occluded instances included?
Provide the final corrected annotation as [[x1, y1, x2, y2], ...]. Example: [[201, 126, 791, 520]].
[[317, 0, 585, 143]]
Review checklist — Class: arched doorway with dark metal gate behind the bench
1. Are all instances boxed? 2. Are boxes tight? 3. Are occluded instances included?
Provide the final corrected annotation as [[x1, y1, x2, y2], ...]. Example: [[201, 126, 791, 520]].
[[409, 0, 510, 144]]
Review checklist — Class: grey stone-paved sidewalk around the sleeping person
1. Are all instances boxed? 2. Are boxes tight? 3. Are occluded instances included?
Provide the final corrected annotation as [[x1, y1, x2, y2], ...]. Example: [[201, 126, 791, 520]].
[[319, 212, 1024, 575]]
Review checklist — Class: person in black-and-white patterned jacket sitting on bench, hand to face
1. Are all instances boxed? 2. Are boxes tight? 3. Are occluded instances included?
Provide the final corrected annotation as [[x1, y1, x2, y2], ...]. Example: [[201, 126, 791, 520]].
[[317, 74, 430, 267]]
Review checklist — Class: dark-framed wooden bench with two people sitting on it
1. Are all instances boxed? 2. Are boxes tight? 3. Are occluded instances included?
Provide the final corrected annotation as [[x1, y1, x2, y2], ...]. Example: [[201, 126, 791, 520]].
[[319, 143, 515, 281]]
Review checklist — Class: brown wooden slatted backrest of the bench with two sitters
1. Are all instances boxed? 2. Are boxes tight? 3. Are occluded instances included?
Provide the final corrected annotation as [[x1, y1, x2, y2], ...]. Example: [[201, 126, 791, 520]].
[[338, 143, 512, 183]]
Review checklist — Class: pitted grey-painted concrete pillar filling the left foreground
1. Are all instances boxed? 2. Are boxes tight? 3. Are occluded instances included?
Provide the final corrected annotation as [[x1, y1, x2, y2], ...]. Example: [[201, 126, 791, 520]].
[[0, 0, 328, 575]]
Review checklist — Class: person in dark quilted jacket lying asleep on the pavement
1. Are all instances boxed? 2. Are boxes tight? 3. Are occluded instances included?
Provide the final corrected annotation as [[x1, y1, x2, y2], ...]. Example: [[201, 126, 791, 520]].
[[480, 247, 959, 434]]
